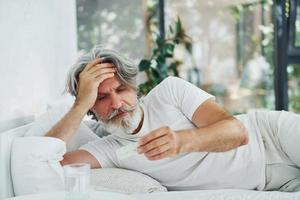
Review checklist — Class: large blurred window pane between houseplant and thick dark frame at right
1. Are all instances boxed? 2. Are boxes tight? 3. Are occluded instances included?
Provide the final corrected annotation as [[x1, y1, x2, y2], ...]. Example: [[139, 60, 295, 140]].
[[165, 0, 275, 114]]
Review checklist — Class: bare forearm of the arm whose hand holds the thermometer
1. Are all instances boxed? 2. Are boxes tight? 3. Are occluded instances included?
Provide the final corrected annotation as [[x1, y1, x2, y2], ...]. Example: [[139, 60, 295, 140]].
[[179, 117, 248, 152]]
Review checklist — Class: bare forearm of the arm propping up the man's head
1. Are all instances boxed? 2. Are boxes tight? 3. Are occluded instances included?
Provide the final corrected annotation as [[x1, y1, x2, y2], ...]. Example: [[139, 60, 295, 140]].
[[46, 104, 87, 143]]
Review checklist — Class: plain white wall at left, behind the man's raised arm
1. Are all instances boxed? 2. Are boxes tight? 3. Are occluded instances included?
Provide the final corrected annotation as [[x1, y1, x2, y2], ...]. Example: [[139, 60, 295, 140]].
[[0, 0, 77, 131]]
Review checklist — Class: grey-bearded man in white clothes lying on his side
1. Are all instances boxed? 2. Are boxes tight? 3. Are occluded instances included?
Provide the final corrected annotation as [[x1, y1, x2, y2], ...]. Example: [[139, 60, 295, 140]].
[[47, 47, 300, 191]]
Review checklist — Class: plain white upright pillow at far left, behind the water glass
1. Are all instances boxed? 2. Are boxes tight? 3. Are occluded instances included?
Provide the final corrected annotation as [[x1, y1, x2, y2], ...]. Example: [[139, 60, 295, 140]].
[[11, 137, 66, 195]]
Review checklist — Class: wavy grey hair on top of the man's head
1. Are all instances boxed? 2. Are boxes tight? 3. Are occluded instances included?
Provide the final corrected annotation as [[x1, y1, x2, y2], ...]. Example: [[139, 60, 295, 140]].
[[65, 46, 138, 97]]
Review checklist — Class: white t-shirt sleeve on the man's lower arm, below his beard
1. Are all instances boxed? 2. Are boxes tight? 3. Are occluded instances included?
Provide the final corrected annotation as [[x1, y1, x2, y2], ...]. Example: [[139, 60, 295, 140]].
[[79, 136, 121, 168]]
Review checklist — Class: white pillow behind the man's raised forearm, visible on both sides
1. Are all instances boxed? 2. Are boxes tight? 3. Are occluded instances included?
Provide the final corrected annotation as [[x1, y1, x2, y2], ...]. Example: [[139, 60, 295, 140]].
[[25, 104, 99, 152]]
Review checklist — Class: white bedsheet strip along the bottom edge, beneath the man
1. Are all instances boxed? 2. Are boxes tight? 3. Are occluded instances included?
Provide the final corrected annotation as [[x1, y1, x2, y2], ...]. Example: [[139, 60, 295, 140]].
[[7, 190, 300, 200]]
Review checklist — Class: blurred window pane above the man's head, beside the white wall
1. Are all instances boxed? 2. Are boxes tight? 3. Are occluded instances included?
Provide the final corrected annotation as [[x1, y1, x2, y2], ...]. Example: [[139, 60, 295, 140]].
[[77, 0, 145, 60]]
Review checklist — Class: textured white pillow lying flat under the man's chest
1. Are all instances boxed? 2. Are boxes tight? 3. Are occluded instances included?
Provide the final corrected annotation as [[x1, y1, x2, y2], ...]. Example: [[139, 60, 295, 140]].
[[91, 168, 167, 194]]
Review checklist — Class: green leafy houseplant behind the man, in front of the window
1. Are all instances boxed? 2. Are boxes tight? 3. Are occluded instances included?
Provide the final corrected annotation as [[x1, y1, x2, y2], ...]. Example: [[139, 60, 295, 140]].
[[139, 17, 192, 94]]
